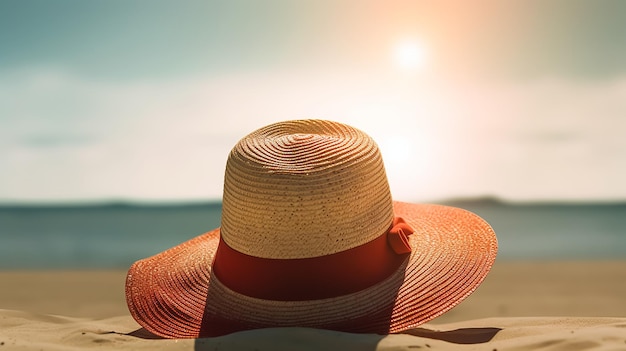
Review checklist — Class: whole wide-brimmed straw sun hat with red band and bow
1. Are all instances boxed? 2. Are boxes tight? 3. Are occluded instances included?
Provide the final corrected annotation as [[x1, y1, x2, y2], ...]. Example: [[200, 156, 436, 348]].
[[126, 120, 497, 338]]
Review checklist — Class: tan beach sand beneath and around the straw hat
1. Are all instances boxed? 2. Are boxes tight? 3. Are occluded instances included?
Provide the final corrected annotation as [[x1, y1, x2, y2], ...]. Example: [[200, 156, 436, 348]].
[[0, 261, 626, 351]]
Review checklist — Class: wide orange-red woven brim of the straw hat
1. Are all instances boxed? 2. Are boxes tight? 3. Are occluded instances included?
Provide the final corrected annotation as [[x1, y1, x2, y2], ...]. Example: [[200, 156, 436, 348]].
[[126, 202, 498, 338]]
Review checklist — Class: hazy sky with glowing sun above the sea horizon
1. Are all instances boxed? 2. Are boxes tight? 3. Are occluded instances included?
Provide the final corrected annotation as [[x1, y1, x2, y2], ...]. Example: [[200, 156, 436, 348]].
[[0, 0, 626, 203]]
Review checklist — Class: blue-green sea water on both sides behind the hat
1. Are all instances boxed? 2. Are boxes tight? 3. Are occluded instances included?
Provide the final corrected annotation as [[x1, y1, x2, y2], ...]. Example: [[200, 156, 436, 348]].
[[0, 200, 626, 269]]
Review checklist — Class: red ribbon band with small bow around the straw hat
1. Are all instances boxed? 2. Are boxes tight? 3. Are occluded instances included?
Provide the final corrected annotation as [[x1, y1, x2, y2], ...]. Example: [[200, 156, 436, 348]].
[[213, 217, 413, 301]]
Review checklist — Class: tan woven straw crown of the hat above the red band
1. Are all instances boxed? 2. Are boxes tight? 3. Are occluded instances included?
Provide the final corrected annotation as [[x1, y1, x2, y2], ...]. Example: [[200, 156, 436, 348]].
[[221, 120, 393, 259]]
